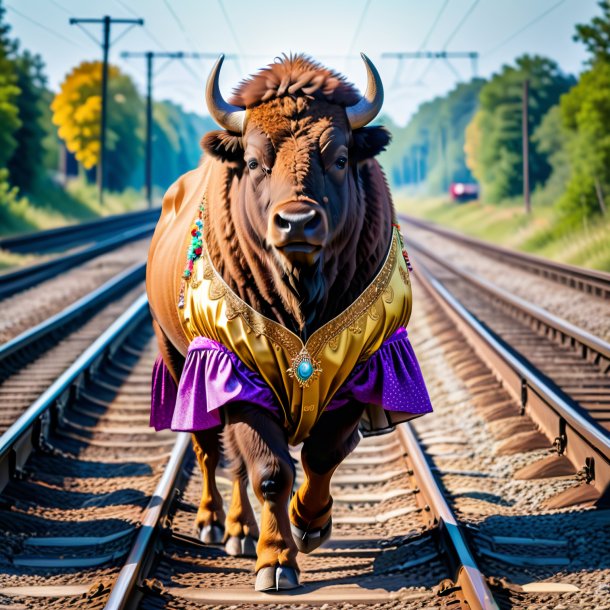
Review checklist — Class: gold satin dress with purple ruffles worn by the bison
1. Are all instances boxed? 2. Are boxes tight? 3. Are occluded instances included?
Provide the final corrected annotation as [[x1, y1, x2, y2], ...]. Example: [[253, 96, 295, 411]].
[[151, 223, 432, 444]]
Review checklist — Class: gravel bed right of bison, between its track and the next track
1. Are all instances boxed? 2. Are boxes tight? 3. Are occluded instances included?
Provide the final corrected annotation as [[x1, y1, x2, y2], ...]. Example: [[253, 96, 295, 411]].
[[410, 285, 610, 609]]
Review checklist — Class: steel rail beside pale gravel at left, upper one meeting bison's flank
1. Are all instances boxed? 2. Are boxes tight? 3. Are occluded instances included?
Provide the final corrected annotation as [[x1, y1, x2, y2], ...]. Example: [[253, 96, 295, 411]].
[[0, 263, 146, 368]]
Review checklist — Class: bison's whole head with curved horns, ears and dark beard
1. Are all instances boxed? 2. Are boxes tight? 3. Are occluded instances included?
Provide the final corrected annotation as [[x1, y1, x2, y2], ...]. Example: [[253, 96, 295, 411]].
[[202, 55, 389, 330]]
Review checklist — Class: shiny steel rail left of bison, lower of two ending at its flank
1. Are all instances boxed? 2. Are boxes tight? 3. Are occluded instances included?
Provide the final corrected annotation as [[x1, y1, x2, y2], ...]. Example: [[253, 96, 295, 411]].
[[0, 294, 148, 492]]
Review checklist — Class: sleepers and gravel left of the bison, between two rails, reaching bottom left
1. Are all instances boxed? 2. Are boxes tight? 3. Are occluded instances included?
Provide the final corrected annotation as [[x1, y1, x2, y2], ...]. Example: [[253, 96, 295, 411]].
[[0, 319, 175, 609]]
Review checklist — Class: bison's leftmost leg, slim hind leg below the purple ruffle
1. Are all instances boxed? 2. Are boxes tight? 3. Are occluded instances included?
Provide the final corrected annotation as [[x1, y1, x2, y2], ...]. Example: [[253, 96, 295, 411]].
[[193, 427, 225, 544]]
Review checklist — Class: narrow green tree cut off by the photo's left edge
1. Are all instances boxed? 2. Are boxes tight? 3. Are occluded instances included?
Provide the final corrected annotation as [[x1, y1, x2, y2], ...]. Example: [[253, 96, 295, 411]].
[[0, 0, 21, 168]]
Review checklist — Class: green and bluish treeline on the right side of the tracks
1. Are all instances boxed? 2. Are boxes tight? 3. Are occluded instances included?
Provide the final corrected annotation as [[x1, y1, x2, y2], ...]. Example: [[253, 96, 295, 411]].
[[384, 1, 610, 220]]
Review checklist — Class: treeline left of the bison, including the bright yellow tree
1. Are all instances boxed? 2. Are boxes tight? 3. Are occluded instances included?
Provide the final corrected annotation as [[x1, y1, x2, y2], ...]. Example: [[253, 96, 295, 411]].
[[0, 0, 214, 208]]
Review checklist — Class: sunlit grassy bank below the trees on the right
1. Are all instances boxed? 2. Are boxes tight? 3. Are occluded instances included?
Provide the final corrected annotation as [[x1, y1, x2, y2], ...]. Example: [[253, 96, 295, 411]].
[[394, 193, 610, 271]]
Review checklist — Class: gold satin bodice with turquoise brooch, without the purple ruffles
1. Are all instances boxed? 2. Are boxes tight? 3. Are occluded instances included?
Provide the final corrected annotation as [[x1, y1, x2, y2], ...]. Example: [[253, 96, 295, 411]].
[[178, 228, 412, 445]]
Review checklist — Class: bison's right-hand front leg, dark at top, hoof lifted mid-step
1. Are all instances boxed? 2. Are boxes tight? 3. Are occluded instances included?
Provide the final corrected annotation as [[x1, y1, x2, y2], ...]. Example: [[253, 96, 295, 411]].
[[290, 404, 364, 553]]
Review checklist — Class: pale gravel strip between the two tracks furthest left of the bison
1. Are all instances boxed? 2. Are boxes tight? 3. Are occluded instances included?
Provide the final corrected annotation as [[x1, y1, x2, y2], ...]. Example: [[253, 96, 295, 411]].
[[0, 238, 149, 344]]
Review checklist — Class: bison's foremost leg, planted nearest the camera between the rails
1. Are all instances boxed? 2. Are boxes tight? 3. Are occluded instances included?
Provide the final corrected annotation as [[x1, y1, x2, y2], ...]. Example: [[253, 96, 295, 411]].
[[227, 406, 299, 591]]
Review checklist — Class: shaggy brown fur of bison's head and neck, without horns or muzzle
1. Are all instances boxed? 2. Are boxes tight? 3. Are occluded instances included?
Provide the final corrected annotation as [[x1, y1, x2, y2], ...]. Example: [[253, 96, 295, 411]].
[[198, 56, 393, 336]]
